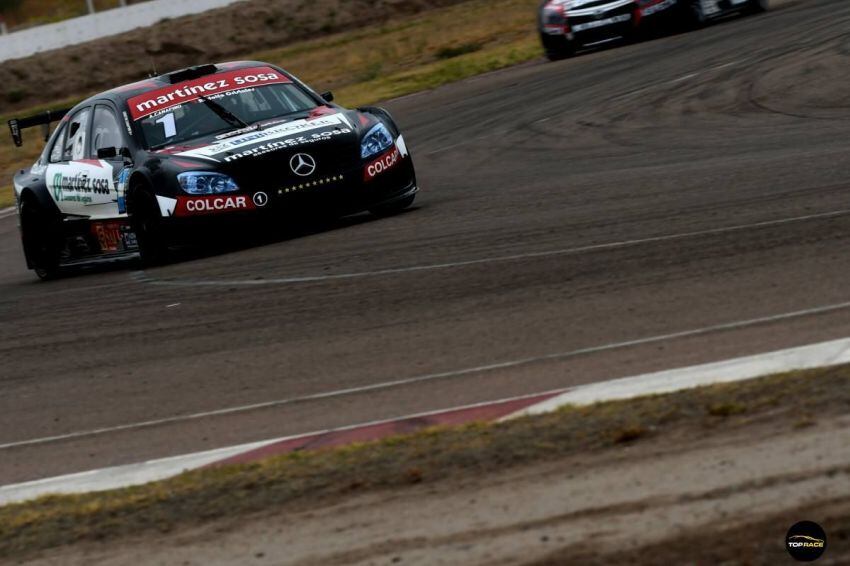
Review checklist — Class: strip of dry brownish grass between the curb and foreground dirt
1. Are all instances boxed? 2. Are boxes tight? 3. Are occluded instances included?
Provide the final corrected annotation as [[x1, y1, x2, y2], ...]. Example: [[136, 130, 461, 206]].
[[0, 366, 850, 558]]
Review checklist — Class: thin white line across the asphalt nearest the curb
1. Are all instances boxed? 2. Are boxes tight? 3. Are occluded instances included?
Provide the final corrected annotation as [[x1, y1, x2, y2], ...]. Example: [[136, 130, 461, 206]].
[[0, 302, 850, 450]]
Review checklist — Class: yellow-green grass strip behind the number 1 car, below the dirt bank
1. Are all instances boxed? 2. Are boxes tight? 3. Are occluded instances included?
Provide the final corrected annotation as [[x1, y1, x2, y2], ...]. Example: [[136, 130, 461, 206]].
[[0, 0, 542, 208]]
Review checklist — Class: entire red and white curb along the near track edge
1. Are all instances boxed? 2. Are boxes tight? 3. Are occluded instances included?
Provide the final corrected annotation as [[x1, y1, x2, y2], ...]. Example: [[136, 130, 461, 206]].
[[0, 339, 850, 505]]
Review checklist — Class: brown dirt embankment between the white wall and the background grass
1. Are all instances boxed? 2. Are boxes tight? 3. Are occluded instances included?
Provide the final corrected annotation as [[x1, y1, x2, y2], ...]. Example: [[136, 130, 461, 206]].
[[0, 0, 470, 112]]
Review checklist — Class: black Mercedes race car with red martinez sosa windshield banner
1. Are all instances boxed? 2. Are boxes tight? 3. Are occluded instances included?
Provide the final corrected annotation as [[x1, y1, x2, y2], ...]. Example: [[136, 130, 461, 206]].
[[9, 61, 418, 278]]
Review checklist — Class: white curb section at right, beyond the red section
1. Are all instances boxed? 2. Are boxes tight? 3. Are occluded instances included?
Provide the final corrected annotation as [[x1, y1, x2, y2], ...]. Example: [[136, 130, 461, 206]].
[[507, 338, 850, 418]]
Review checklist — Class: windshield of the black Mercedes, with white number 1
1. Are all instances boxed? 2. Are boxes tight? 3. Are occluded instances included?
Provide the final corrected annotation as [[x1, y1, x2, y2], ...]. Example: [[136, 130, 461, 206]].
[[139, 83, 318, 149]]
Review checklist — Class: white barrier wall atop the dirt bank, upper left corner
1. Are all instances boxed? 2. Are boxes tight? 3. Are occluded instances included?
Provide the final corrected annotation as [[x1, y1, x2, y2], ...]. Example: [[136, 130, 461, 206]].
[[0, 0, 238, 62]]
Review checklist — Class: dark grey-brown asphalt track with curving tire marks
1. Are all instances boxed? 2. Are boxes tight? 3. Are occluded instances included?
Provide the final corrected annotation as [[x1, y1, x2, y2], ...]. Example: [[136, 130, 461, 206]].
[[0, 0, 850, 484]]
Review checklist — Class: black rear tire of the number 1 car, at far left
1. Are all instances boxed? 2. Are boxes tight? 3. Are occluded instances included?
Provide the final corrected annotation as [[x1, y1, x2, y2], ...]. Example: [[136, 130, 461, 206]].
[[20, 197, 62, 281]]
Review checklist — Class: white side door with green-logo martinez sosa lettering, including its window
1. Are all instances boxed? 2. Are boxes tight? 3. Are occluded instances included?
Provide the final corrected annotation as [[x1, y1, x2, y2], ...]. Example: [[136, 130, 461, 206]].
[[46, 105, 120, 219]]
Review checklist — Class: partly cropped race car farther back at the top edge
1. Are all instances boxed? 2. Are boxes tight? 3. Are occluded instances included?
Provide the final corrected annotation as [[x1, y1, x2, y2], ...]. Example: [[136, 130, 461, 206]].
[[538, 0, 769, 61]]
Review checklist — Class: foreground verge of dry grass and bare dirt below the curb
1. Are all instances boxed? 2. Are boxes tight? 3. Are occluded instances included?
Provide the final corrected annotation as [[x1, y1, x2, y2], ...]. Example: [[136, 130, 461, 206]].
[[6, 366, 850, 566]]
